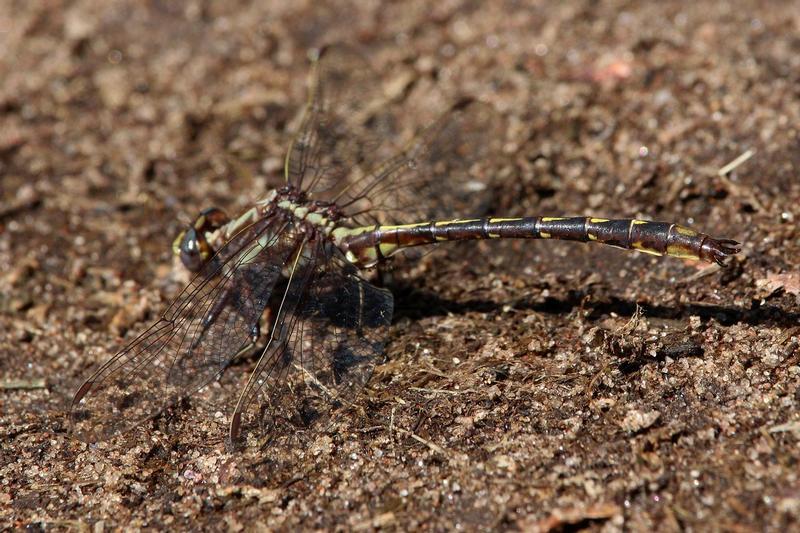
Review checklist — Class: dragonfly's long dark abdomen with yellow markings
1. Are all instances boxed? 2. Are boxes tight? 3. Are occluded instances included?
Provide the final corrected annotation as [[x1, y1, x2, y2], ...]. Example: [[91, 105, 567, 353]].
[[334, 217, 739, 266]]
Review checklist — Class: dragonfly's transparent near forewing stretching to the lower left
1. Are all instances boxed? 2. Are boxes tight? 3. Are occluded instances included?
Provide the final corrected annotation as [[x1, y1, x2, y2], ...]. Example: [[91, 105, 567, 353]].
[[70, 215, 302, 441]]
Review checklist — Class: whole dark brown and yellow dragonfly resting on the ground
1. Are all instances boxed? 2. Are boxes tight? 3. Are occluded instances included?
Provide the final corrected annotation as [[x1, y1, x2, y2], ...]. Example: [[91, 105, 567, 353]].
[[69, 45, 740, 442]]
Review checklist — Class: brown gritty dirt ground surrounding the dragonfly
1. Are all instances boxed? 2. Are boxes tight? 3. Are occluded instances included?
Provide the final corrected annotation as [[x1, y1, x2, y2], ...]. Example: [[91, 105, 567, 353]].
[[0, 0, 800, 531]]
